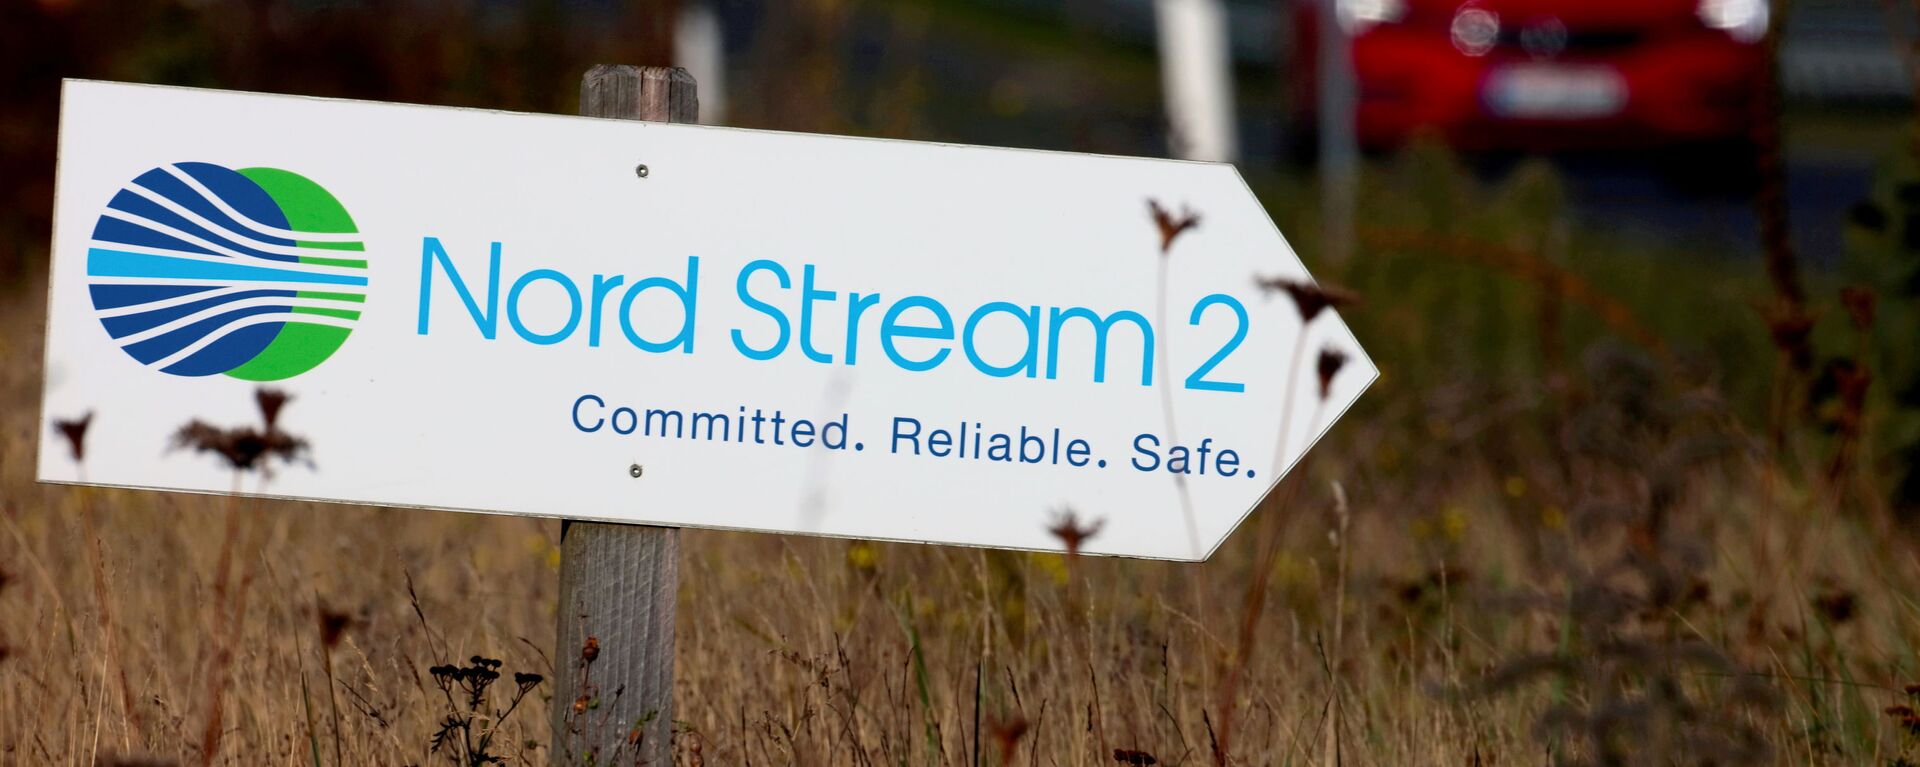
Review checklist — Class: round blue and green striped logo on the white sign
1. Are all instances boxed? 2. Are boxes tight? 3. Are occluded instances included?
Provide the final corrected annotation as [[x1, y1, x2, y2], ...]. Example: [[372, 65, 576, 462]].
[[86, 161, 367, 381]]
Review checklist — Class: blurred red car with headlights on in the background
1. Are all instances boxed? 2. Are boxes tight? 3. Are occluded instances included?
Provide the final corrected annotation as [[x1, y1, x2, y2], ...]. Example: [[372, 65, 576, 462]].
[[1292, 0, 1768, 154]]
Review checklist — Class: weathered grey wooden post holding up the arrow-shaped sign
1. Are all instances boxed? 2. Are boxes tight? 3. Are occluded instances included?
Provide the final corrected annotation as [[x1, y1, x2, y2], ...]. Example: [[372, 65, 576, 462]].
[[551, 63, 699, 765]]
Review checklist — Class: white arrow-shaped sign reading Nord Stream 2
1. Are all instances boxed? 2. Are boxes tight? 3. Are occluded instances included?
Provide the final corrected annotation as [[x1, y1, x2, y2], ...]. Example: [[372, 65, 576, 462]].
[[40, 81, 1377, 559]]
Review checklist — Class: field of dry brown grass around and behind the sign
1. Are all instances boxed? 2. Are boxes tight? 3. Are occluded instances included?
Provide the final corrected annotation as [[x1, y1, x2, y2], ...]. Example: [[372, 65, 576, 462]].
[[0, 155, 1920, 765]]
